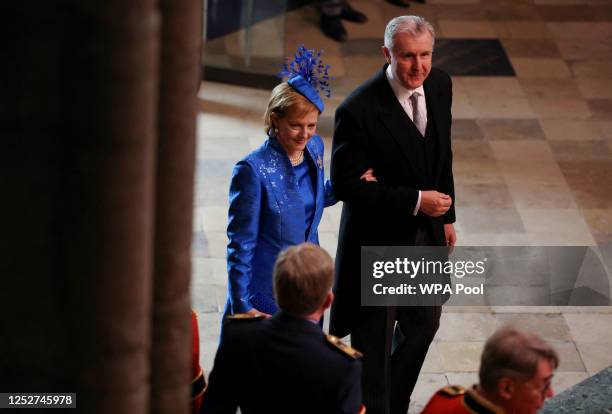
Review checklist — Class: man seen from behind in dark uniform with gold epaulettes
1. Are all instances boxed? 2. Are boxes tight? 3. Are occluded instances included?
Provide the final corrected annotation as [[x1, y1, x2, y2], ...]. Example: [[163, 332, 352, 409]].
[[202, 243, 363, 414]]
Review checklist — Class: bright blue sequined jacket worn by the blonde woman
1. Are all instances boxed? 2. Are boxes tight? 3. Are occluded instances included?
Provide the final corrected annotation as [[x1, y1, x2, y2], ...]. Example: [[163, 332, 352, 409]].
[[225, 135, 336, 314]]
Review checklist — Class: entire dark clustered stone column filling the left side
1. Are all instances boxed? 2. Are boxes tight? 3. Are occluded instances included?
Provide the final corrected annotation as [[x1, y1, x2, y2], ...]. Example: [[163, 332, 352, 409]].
[[0, 0, 201, 414]]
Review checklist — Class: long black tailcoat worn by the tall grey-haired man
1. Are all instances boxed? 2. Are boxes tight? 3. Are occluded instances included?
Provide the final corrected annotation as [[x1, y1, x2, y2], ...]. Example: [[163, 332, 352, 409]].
[[330, 65, 455, 337]]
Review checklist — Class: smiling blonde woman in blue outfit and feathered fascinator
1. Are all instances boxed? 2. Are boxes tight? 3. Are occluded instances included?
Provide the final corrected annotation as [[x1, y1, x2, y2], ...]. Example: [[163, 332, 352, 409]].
[[225, 46, 373, 316]]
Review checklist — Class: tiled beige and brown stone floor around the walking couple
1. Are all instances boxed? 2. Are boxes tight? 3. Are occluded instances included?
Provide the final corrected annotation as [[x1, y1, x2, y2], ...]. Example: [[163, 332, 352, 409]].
[[192, 0, 612, 412]]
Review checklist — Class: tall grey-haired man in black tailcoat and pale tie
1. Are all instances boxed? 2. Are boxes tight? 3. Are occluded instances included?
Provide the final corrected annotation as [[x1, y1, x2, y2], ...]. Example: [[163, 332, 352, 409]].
[[330, 16, 456, 414]]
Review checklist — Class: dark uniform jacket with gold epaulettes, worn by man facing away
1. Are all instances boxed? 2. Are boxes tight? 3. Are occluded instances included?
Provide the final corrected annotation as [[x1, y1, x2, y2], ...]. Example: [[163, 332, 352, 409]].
[[202, 312, 361, 414]]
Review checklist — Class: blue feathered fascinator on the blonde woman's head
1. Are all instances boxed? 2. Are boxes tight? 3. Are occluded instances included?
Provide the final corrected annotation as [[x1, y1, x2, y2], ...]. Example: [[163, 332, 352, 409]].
[[279, 45, 331, 112]]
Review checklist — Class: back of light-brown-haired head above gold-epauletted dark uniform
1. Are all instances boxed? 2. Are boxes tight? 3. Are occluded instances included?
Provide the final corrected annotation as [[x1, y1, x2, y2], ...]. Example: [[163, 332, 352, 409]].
[[274, 243, 334, 317]]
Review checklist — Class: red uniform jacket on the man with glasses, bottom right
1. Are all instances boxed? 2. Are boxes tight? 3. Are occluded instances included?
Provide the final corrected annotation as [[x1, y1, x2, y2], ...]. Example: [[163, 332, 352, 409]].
[[421, 385, 504, 414]]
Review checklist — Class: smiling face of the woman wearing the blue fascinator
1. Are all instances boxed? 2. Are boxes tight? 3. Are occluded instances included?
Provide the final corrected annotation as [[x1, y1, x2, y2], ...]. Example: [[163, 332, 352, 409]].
[[274, 106, 319, 156]]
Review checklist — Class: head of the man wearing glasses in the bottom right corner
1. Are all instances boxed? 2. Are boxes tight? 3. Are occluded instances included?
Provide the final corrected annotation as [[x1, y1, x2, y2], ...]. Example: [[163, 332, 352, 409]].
[[479, 326, 559, 413]]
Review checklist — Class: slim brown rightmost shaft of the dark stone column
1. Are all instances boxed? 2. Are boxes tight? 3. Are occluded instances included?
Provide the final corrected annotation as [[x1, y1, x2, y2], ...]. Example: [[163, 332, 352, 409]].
[[151, 0, 202, 414]]
